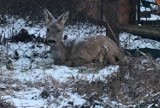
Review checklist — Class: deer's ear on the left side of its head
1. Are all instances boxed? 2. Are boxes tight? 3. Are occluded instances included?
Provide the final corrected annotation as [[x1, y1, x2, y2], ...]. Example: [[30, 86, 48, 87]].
[[44, 9, 56, 24]]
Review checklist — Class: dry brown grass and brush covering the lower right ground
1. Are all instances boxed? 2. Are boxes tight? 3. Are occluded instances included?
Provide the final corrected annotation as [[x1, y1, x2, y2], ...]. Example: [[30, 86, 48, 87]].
[[67, 57, 160, 106]]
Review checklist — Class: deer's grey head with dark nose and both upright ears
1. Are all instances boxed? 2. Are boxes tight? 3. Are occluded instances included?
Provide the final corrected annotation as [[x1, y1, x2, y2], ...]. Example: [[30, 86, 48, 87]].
[[44, 9, 69, 46]]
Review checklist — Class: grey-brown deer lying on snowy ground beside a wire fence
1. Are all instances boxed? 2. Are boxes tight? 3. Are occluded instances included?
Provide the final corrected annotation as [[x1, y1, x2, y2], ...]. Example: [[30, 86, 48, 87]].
[[44, 9, 122, 67]]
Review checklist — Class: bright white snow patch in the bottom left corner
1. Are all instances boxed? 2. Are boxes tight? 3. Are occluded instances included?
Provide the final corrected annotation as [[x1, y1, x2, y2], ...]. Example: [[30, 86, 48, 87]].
[[3, 88, 46, 108]]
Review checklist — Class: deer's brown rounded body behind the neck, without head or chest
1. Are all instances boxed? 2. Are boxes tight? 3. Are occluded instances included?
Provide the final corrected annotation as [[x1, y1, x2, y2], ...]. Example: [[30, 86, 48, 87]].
[[70, 35, 122, 66]]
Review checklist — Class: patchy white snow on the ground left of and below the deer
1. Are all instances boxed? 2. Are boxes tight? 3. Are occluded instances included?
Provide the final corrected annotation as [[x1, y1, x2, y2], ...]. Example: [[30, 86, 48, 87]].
[[0, 43, 119, 108]]
